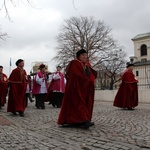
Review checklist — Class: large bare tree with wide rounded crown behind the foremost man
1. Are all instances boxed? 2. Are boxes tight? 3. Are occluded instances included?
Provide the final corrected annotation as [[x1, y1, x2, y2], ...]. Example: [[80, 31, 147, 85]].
[[54, 17, 119, 68]]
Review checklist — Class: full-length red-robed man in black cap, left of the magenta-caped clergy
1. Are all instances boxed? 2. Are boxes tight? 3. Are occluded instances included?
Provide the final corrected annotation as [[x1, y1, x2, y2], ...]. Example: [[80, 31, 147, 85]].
[[7, 59, 27, 117]]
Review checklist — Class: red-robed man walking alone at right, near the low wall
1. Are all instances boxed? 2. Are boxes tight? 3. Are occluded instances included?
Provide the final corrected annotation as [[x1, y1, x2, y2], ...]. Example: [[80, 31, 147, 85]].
[[113, 63, 138, 110]]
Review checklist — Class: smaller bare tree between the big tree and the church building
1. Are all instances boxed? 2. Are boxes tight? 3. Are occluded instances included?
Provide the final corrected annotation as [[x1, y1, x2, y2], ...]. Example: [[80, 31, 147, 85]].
[[99, 49, 126, 90]]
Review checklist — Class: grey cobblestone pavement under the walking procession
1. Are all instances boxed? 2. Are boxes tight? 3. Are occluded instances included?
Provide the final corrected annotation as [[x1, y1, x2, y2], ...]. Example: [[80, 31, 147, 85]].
[[0, 101, 150, 150]]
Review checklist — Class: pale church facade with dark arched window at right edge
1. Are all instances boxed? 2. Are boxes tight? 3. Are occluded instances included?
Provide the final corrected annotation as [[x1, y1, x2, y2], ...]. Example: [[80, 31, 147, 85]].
[[130, 32, 150, 89]]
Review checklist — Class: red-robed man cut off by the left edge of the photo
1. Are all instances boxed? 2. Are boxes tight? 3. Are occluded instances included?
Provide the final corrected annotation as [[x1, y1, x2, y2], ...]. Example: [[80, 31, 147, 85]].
[[0, 66, 8, 109]]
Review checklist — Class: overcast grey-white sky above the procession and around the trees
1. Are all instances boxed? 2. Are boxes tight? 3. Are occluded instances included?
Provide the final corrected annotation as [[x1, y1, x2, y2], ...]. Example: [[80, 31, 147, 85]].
[[0, 0, 150, 75]]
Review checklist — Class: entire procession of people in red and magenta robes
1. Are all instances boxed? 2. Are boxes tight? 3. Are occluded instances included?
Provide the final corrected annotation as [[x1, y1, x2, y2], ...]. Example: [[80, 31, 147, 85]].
[[0, 49, 138, 129]]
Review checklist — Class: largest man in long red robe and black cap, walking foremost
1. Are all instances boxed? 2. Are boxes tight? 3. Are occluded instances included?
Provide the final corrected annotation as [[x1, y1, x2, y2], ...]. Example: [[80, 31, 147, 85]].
[[58, 49, 97, 129]]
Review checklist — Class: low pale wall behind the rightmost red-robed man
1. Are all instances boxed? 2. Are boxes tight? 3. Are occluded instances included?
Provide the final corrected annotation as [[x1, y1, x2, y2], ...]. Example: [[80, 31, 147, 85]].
[[95, 89, 150, 103]]
